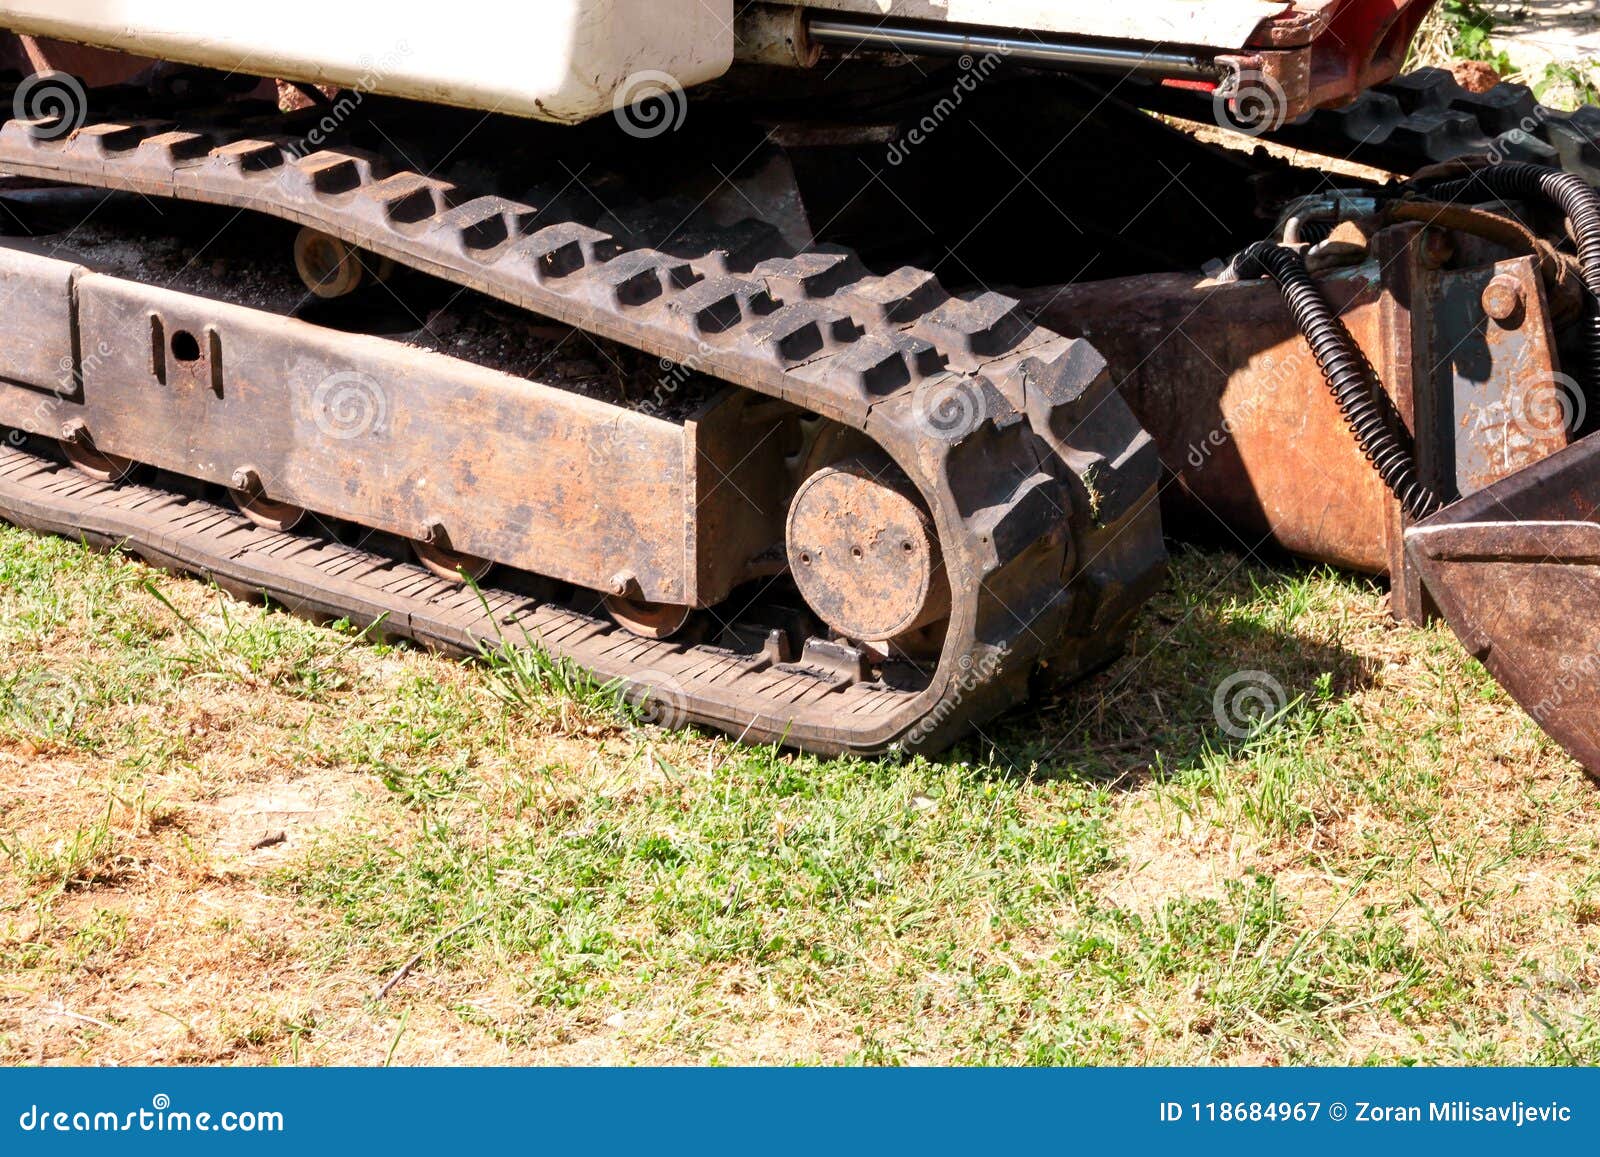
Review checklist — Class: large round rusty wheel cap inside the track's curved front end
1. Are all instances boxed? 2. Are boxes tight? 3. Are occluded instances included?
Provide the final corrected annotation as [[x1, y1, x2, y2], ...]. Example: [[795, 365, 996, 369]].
[[786, 456, 950, 650]]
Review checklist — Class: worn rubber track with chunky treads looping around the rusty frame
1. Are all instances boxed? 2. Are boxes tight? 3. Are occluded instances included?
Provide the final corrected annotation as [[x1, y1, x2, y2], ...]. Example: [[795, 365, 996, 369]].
[[0, 92, 1165, 754]]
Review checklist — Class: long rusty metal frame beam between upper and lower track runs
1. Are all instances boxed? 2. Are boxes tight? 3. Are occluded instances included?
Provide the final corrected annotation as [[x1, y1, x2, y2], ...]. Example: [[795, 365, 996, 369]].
[[0, 248, 794, 607]]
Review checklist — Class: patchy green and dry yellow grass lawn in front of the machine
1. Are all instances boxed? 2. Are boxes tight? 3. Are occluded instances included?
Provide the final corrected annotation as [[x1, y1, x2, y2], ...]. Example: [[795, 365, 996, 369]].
[[0, 530, 1600, 1064]]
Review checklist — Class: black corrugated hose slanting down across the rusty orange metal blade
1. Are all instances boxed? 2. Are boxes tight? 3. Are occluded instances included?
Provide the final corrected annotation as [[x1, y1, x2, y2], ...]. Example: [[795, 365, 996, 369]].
[[1234, 242, 1442, 518]]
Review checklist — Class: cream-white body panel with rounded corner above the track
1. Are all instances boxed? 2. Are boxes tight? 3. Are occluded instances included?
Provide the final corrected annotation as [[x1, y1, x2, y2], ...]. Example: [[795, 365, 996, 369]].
[[0, 0, 733, 122]]
